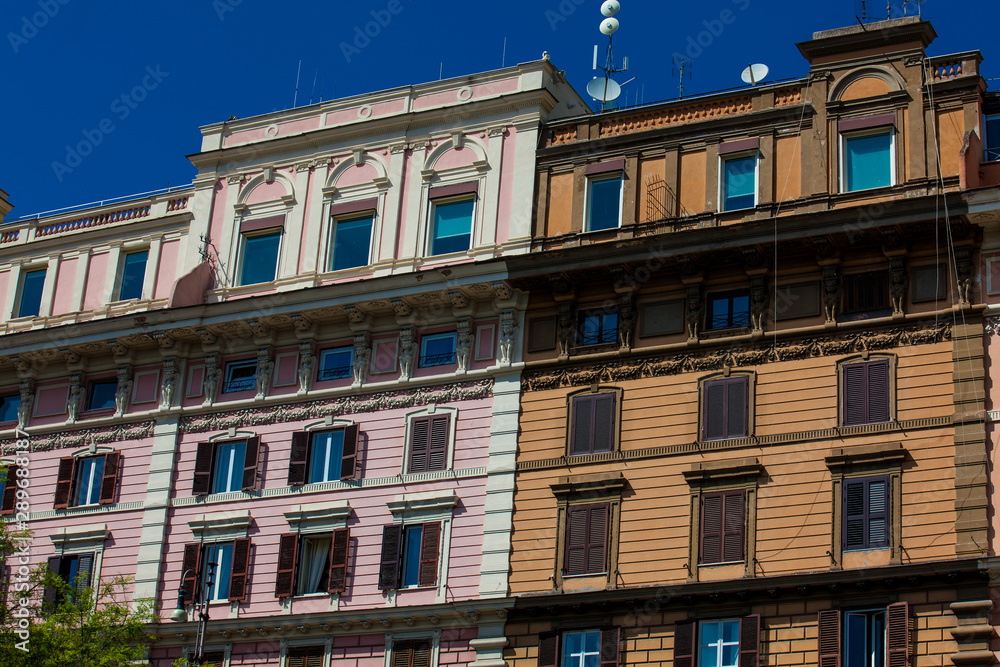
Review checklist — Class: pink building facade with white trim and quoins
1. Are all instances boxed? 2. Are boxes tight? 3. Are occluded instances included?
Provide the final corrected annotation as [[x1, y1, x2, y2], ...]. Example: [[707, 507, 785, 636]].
[[0, 62, 586, 667]]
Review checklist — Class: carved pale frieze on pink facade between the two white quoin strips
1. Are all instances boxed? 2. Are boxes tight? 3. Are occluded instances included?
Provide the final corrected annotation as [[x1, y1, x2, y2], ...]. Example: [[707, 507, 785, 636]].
[[182, 379, 493, 442]]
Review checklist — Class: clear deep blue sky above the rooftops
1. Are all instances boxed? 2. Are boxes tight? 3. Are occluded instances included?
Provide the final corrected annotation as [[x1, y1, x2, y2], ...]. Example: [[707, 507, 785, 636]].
[[0, 0, 1000, 219]]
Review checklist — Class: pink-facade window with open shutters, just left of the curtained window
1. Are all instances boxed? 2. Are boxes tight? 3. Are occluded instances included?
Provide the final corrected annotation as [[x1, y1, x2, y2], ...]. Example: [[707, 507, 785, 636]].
[[181, 538, 250, 604]]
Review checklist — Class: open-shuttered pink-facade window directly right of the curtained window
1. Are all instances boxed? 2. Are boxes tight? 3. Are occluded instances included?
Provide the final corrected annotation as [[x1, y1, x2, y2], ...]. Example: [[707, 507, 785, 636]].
[[379, 522, 441, 590]]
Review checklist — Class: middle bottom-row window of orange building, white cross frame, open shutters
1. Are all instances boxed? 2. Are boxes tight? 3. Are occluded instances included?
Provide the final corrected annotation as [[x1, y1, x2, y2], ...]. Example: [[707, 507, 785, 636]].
[[674, 614, 760, 667]]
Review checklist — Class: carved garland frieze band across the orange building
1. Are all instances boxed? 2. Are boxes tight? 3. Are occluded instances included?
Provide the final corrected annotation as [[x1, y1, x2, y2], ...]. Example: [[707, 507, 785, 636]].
[[523, 323, 951, 391]]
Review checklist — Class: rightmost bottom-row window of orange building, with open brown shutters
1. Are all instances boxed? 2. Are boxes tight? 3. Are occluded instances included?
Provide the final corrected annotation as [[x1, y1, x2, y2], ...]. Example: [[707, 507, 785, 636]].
[[817, 602, 910, 667]]
